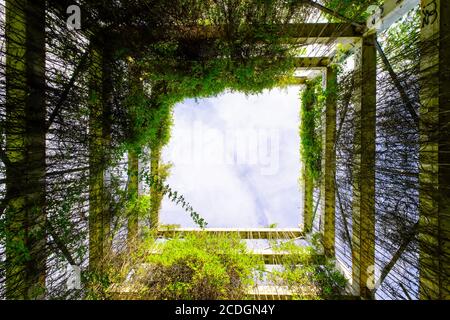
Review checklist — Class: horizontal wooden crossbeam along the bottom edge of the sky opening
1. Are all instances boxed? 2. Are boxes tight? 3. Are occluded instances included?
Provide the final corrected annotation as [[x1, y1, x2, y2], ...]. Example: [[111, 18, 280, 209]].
[[158, 228, 304, 239]]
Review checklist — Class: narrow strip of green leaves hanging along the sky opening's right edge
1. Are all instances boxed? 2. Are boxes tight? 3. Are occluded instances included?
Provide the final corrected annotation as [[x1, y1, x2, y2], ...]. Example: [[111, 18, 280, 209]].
[[300, 78, 326, 182]]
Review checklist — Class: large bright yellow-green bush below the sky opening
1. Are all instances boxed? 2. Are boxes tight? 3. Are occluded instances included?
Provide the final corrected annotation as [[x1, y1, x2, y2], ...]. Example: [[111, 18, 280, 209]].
[[135, 234, 263, 300]]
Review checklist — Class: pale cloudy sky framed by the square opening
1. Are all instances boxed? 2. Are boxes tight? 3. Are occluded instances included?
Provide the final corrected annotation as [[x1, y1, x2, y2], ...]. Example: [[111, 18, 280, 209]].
[[160, 86, 300, 227]]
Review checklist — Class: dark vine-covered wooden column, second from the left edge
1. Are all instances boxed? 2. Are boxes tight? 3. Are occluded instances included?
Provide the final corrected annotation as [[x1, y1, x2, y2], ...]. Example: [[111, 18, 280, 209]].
[[89, 42, 112, 271]]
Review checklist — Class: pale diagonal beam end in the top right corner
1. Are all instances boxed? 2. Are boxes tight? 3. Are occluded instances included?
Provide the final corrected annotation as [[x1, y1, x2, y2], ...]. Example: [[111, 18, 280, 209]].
[[367, 0, 420, 32]]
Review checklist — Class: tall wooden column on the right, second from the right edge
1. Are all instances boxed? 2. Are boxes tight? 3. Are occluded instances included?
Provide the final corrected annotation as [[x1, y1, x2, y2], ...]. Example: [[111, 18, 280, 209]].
[[352, 35, 376, 298]]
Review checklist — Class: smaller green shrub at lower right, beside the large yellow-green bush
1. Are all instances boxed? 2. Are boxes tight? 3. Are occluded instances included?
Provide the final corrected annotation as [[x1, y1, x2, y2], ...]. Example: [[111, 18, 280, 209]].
[[270, 242, 347, 300]]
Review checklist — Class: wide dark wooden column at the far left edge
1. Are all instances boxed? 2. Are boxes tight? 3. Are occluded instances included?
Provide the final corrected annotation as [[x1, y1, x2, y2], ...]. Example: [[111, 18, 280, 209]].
[[3, 0, 47, 299]]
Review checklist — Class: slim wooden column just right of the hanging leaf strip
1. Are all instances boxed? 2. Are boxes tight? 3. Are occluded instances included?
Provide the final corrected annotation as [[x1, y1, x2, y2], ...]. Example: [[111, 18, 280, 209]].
[[321, 66, 337, 257]]
